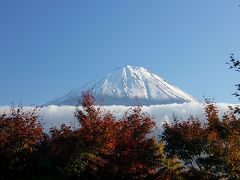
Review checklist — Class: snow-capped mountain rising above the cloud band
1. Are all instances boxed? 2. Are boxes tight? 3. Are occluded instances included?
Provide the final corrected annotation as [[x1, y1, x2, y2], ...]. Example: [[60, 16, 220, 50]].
[[45, 65, 198, 106]]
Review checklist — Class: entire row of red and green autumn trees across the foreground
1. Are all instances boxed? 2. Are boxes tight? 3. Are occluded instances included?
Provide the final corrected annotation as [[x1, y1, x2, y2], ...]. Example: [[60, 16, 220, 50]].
[[0, 91, 240, 180]]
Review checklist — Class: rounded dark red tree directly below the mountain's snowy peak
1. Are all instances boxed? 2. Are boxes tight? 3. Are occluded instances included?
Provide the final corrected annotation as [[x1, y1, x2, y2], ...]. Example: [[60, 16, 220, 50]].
[[112, 107, 161, 179]]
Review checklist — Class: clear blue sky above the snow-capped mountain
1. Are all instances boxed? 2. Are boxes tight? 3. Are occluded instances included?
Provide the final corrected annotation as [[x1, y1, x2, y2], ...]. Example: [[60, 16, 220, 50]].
[[0, 0, 240, 105]]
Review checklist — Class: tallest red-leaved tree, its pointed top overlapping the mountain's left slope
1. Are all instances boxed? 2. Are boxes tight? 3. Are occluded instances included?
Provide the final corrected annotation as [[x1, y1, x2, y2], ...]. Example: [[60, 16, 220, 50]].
[[65, 94, 118, 179]]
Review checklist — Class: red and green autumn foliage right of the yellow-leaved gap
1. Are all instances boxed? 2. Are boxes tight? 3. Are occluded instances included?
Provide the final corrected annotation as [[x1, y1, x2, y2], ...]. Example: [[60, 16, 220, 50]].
[[162, 100, 240, 179]]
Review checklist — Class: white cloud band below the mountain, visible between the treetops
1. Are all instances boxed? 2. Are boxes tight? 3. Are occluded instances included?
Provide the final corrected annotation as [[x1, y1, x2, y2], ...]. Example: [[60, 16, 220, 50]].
[[0, 103, 238, 132]]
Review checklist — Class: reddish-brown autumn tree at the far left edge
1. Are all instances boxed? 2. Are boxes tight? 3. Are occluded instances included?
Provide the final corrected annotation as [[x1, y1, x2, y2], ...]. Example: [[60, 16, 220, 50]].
[[0, 106, 44, 179]]
